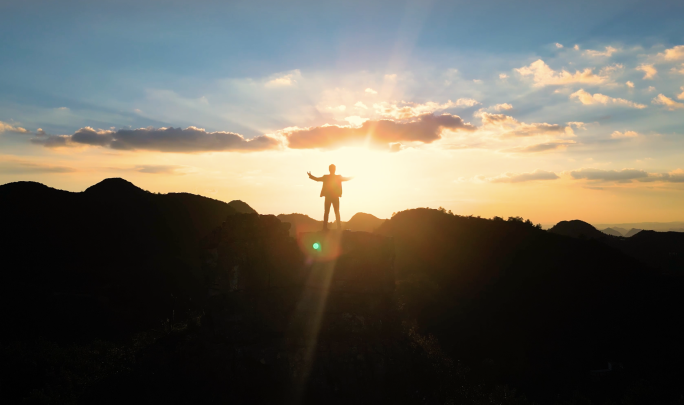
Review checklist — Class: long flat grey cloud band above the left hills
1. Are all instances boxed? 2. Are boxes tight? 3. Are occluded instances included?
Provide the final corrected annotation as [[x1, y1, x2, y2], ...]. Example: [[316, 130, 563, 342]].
[[31, 127, 280, 153]]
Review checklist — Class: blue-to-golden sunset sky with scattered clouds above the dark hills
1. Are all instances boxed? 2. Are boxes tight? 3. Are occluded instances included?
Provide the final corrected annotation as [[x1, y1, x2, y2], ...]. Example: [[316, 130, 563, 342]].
[[0, 0, 684, 225]]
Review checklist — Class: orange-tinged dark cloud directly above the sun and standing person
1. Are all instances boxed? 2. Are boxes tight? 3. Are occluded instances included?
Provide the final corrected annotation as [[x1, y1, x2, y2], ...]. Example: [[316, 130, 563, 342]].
[[285, 114, 477, 149]]
